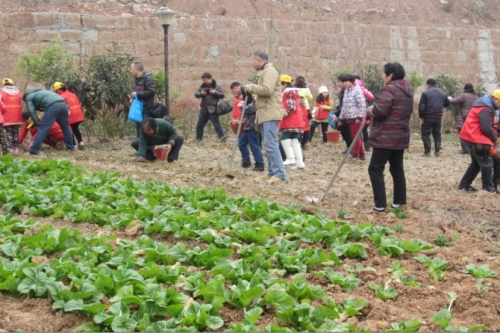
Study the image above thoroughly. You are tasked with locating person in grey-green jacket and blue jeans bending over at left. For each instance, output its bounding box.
[23,88,74,155]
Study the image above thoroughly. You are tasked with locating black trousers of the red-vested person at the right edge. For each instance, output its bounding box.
[458,145,495,192]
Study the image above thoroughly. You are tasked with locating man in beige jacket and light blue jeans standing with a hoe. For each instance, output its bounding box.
[241,51,286,183]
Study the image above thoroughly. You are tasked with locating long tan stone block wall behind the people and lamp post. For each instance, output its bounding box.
[0,13,500,94]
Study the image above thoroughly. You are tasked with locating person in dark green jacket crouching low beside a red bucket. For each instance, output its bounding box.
[132,117,184,163]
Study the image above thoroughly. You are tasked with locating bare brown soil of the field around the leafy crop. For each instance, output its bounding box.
[0,134,500,331]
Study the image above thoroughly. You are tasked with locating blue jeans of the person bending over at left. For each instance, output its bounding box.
[30,102,74,155]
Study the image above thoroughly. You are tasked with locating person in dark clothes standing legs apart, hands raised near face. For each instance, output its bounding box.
[194,72,226,142]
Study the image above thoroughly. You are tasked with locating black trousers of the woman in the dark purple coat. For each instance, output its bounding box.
[368,148,406,208]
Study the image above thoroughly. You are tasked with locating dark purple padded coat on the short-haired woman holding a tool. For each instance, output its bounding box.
[368,79,413,150]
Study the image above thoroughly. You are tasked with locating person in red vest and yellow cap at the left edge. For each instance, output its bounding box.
[0,78,23,154]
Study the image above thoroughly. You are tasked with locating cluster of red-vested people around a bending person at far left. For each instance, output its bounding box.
[0,78,84,155]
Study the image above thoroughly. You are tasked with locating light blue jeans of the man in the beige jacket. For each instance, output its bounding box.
[261,120,286,180]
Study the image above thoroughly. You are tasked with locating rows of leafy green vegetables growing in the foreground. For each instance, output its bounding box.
[0,157,496,332]
